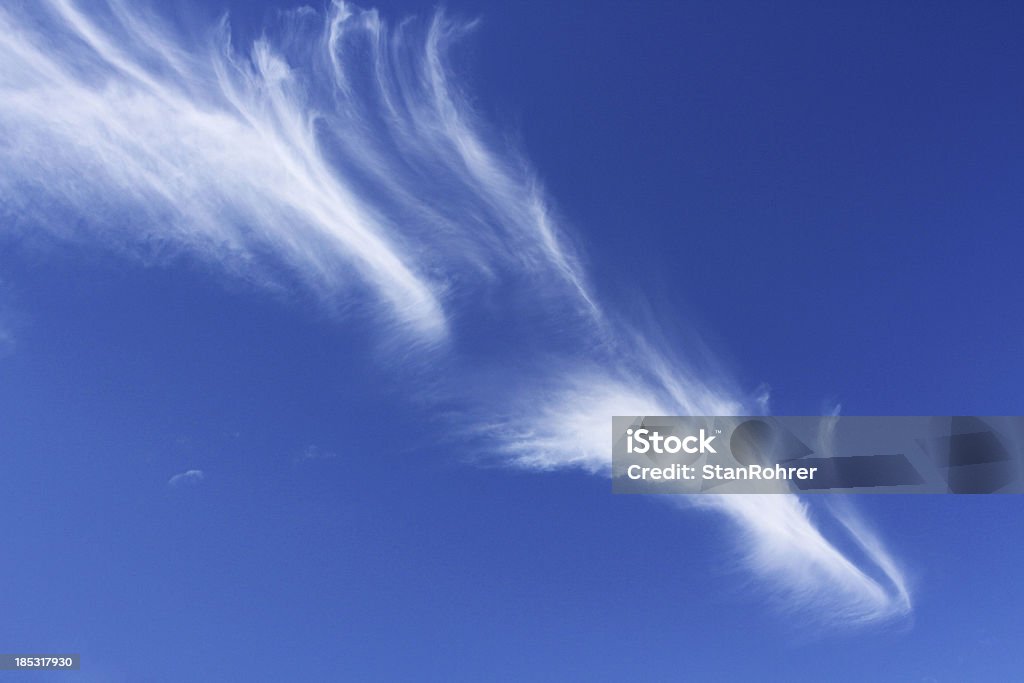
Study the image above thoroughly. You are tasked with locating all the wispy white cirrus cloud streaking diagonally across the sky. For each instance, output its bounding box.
[0,0,910,624]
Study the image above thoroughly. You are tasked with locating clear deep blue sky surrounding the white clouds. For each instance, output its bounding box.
[0,3,1024,681]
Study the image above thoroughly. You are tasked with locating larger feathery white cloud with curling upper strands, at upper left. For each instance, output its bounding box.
[0,0,590,341]
